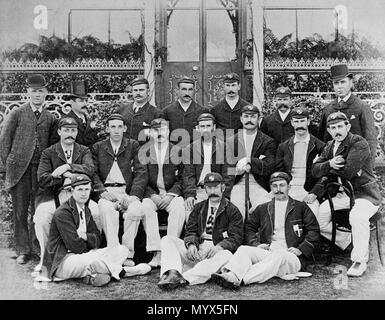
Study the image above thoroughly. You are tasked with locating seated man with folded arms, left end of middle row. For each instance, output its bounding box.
[33,117,101,272]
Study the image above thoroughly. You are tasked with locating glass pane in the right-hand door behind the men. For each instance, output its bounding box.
[206,10,238,62]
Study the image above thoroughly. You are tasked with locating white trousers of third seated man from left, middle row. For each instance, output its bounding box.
[143,197,186,238]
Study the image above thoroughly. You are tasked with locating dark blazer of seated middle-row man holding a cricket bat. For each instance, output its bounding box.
[226,130,277,191]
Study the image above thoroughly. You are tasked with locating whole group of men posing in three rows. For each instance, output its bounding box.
[0,65,381,289]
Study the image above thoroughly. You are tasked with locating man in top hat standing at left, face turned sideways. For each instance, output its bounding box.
[65,80,98,147]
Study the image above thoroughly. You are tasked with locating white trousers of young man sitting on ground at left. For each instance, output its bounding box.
[54,245,128,281]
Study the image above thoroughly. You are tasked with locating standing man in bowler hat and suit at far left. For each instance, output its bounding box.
[0,74,58,264]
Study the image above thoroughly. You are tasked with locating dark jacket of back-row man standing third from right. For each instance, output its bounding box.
[211,98,250,132]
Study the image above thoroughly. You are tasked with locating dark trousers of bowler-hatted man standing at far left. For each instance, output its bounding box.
[10,164,39,255]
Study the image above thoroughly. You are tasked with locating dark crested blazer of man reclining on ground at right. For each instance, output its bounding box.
[245,197,320,269]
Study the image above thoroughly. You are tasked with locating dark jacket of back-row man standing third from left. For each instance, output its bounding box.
[118,102,164,144]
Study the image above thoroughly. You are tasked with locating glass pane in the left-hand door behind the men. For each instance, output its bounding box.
[167,10,199,61]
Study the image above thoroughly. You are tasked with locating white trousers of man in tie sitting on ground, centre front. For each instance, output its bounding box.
[160,236,232,285]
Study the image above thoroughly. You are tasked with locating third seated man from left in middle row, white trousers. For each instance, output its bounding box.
[143,118,186,268]
